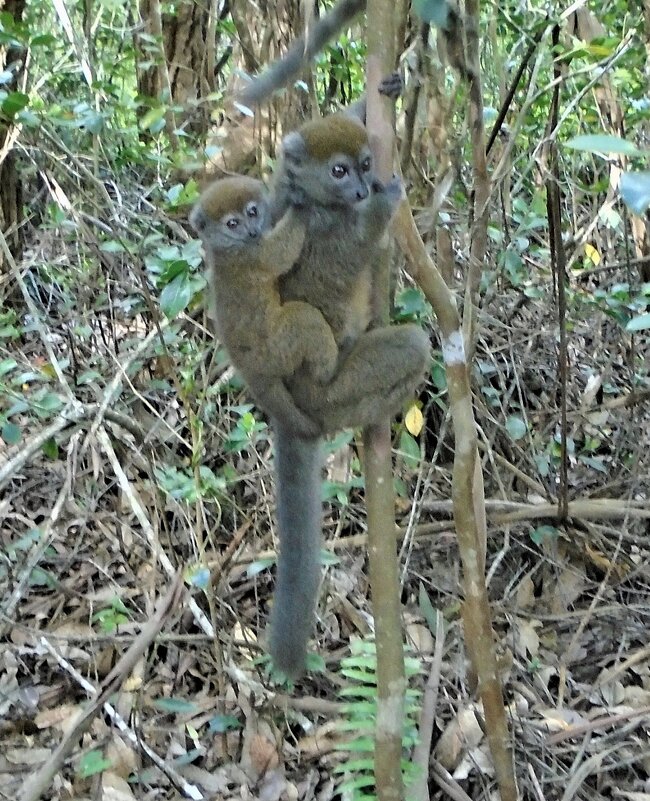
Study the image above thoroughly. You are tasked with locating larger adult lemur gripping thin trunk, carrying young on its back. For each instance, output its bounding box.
[270,113,429,677]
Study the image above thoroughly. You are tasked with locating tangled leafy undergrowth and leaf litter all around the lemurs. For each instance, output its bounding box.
[0,3,650,801]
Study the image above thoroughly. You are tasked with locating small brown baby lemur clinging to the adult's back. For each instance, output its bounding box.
[190,176,338,437]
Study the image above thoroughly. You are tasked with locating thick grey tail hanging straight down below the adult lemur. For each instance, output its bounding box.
[270,426,322,678]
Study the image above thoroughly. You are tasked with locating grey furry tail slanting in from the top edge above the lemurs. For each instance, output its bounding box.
[238,0,366,106]
